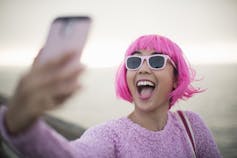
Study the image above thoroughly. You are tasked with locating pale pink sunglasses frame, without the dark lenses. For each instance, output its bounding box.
[125,54,176,70]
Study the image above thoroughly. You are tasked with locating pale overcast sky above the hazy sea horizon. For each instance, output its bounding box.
[0,0,237,66]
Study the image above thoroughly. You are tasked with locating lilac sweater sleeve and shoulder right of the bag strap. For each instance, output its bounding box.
[186,111,221,158]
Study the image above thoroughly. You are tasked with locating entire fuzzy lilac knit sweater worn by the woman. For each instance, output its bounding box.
[0,108,221,158]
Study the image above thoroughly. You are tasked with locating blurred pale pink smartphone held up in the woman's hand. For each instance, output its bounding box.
[38,16,91,66]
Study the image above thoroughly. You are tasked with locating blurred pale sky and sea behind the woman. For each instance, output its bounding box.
[0,0,237,157]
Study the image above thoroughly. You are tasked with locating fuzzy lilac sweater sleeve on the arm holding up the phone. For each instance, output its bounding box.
[0,108,113,158]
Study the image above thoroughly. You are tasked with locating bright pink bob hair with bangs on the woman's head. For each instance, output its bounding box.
[115,35,202,108]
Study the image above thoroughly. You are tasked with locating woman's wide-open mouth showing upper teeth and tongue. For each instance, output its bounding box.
[136,80,156,99]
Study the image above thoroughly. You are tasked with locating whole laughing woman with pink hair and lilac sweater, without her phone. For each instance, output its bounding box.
[0,35,221,158]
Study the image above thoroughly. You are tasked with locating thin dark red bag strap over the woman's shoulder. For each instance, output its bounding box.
[177,110,196,157]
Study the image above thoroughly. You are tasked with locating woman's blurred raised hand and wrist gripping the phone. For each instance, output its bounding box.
[5,53,83,135]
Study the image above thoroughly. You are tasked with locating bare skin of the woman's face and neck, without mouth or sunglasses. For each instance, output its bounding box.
[126,50,176,131]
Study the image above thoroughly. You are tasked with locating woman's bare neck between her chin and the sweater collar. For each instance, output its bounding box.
[128,103,169,131]
